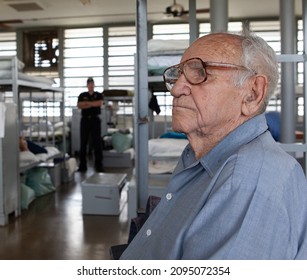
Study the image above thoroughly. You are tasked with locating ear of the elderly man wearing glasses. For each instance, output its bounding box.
[242,75,267,116]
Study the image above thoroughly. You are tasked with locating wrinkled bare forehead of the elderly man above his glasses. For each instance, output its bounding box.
[181,33,242,64]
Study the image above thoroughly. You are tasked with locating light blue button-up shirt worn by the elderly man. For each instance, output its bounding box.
[122,115,307,259]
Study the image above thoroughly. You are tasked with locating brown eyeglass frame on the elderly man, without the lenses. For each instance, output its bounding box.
[163,57,257,91]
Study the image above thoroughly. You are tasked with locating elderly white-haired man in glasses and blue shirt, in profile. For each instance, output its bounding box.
[122,29,307,259]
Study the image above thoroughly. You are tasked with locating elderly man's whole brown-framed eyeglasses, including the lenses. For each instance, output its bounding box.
[163,57,256,91]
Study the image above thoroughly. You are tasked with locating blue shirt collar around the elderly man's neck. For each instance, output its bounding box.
[199,114,268,176]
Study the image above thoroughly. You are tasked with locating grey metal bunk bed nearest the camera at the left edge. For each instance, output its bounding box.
[0,56,66,225]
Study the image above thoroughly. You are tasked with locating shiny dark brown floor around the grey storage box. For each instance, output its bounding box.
[0,166,130,260]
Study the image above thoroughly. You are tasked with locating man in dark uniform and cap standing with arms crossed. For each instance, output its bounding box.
[77,77,103,172]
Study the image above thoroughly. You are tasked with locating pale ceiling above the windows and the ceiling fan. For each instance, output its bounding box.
[0,0,302,30]
